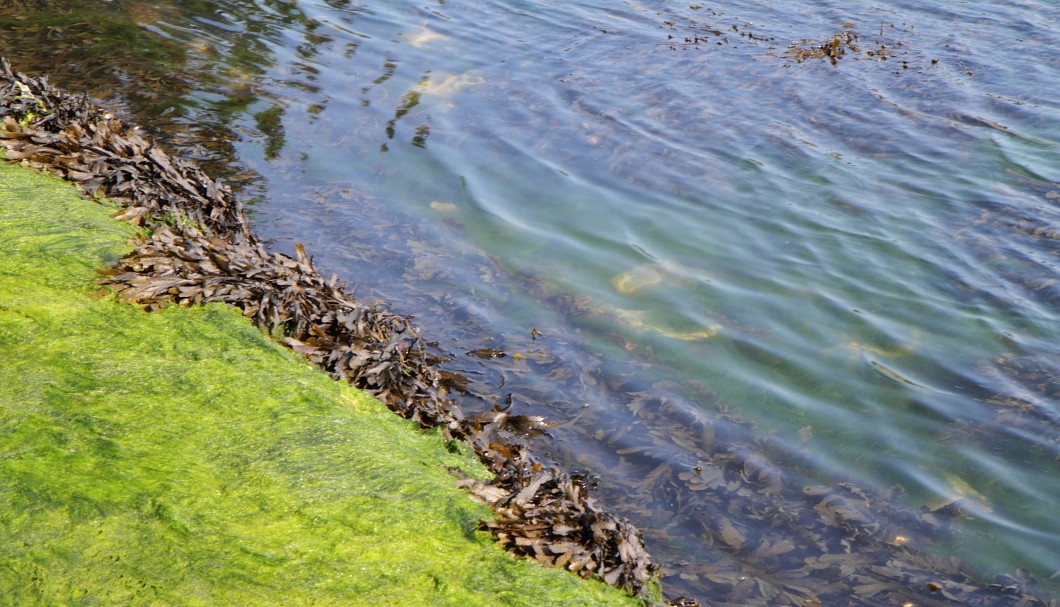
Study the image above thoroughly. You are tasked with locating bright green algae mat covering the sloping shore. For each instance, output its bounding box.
[0,165,640,607]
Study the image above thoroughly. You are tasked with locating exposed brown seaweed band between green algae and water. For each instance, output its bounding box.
[0,59,656,595]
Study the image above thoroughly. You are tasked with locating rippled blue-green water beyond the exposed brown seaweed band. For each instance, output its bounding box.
[0,0,1060,605]
